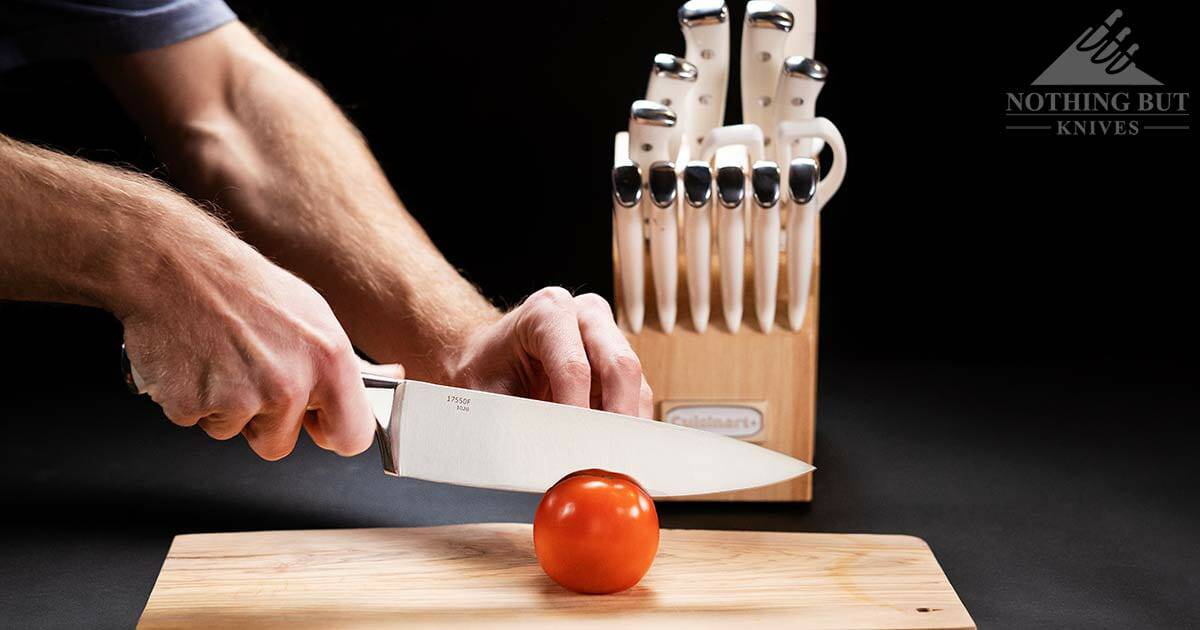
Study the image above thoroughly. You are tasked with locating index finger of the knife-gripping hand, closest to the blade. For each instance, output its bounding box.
[306,342,376,456]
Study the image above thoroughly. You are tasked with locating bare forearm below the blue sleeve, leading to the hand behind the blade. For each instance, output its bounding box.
[96,25,498,379]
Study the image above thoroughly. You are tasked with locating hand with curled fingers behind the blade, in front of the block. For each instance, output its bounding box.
[451,287,654,418]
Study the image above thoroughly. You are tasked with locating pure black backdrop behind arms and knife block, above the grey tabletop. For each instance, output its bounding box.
[0,1,1198,370]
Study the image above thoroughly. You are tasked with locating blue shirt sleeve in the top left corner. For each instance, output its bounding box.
[0,0,238,72]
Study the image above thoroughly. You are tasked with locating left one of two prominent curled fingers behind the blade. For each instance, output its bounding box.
[516,287,592,407]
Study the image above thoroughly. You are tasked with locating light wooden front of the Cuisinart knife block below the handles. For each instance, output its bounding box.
[613,220,821,502]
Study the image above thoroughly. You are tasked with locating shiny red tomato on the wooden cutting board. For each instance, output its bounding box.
[533,468,659,593]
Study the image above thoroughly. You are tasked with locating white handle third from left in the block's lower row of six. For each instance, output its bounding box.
[683,161,713,332]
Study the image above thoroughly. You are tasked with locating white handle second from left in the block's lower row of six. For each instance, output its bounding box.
[649,162,679,332]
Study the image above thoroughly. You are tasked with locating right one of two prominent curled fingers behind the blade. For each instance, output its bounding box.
[575,293,649,415]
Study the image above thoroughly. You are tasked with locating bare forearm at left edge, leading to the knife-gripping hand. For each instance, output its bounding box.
[0,136,250,318]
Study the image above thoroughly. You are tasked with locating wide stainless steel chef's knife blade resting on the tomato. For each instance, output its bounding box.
[372,380,812,497]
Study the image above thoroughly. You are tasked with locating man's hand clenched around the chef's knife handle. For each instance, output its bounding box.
[122,238,374,461]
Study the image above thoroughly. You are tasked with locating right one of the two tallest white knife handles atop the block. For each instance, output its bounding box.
[742,0,794,158]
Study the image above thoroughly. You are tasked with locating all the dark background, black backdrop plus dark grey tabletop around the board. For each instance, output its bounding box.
[0,1,1200,628]
